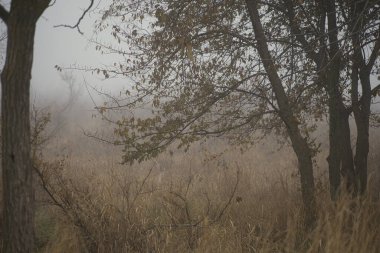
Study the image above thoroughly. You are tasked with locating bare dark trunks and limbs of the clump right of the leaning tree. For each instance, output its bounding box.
[283,0,380,199]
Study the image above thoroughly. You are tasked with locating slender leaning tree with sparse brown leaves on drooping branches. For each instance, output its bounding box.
[93,0,322,227]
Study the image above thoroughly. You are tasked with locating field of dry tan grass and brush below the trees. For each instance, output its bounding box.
[29,128,380,253]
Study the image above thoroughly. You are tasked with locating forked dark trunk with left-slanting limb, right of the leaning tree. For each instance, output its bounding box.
[283,0,355,199]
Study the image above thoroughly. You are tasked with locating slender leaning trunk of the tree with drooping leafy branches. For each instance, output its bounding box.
[246,0,317,229]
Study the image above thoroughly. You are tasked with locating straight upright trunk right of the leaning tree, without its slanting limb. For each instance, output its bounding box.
[324,0,356,200]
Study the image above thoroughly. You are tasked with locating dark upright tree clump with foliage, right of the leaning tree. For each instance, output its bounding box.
[276,0,380,199]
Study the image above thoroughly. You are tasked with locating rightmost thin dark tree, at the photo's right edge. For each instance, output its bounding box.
[344,1,380,194]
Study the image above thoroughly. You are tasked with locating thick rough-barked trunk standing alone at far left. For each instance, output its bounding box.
[1,0,49,253]
